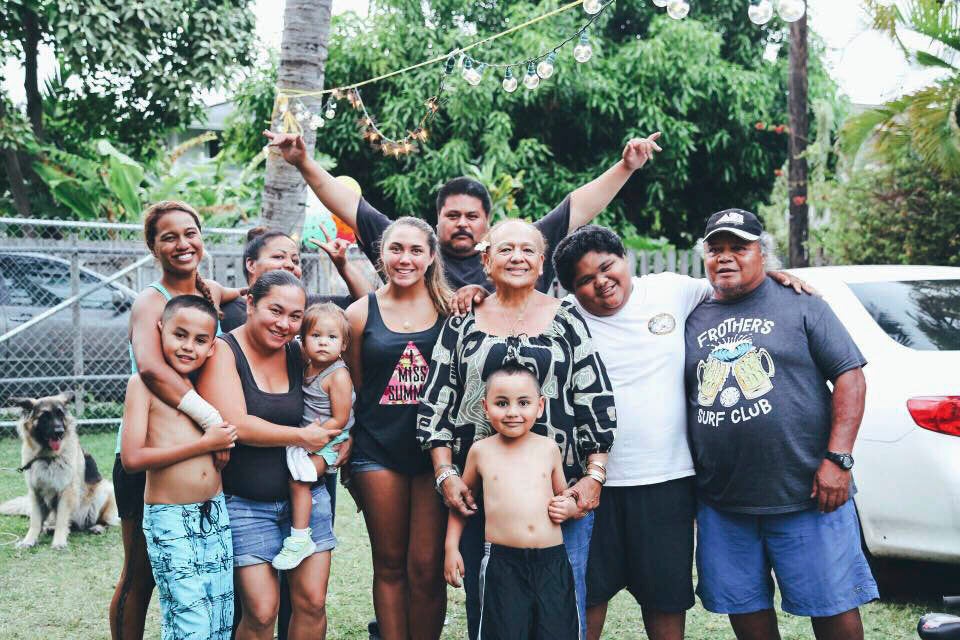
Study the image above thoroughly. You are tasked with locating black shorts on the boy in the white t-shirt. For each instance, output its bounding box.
[587,476,697,613]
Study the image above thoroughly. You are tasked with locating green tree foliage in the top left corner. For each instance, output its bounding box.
[0,0,254,152]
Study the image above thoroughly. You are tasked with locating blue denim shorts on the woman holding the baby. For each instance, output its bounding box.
[227,484,337,567]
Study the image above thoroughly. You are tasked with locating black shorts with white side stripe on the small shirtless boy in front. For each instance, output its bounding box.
[480,542,580,640]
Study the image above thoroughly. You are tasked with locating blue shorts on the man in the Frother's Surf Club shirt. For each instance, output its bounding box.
[697,499,880,618]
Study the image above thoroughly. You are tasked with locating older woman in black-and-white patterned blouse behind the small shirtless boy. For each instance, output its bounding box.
[417,220,616,638]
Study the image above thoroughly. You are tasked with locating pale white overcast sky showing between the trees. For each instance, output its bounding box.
[3,0,935,109]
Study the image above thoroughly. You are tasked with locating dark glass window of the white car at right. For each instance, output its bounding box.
[849,280,960,351]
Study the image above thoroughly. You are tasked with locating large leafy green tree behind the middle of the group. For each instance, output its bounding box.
[225,0,836,244]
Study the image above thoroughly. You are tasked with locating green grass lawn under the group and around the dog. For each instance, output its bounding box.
[0,434,938,640]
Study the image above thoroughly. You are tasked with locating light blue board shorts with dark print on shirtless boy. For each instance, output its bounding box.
[143,493,233,640]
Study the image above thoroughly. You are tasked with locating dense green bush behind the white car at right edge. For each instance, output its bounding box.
[812,154,960,266]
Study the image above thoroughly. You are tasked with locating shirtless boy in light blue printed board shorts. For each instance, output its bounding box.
[120,296,237,640]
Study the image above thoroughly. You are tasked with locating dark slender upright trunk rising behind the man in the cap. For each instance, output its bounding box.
[787,16,810,267]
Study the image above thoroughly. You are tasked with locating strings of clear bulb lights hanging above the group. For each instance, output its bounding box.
[272,0,806,158]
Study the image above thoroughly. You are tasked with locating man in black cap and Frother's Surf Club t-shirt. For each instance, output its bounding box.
[685,209,878,640]
